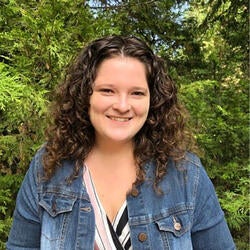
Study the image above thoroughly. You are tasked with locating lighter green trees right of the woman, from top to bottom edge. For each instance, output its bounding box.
[182,0,249,249]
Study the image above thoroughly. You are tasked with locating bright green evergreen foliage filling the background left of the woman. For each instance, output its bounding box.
[0,0,95,249]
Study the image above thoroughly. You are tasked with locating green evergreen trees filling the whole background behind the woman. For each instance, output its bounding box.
[0,0,249,249]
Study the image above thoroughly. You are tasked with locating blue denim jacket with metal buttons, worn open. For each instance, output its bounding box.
[7,147,235,250]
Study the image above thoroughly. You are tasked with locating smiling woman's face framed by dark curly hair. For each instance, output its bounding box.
[89,56,150,143]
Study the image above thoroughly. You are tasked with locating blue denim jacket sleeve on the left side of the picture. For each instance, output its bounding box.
[7,151,41,250]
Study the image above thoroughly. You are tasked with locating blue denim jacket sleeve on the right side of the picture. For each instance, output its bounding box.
[192,166,236,250]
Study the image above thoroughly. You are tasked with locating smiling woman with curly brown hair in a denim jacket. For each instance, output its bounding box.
[7,36,235,250]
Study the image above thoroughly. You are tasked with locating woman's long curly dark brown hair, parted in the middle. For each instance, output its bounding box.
[43,36,189,189]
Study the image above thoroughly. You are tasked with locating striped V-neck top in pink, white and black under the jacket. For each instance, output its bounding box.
[83,165,132,250]
